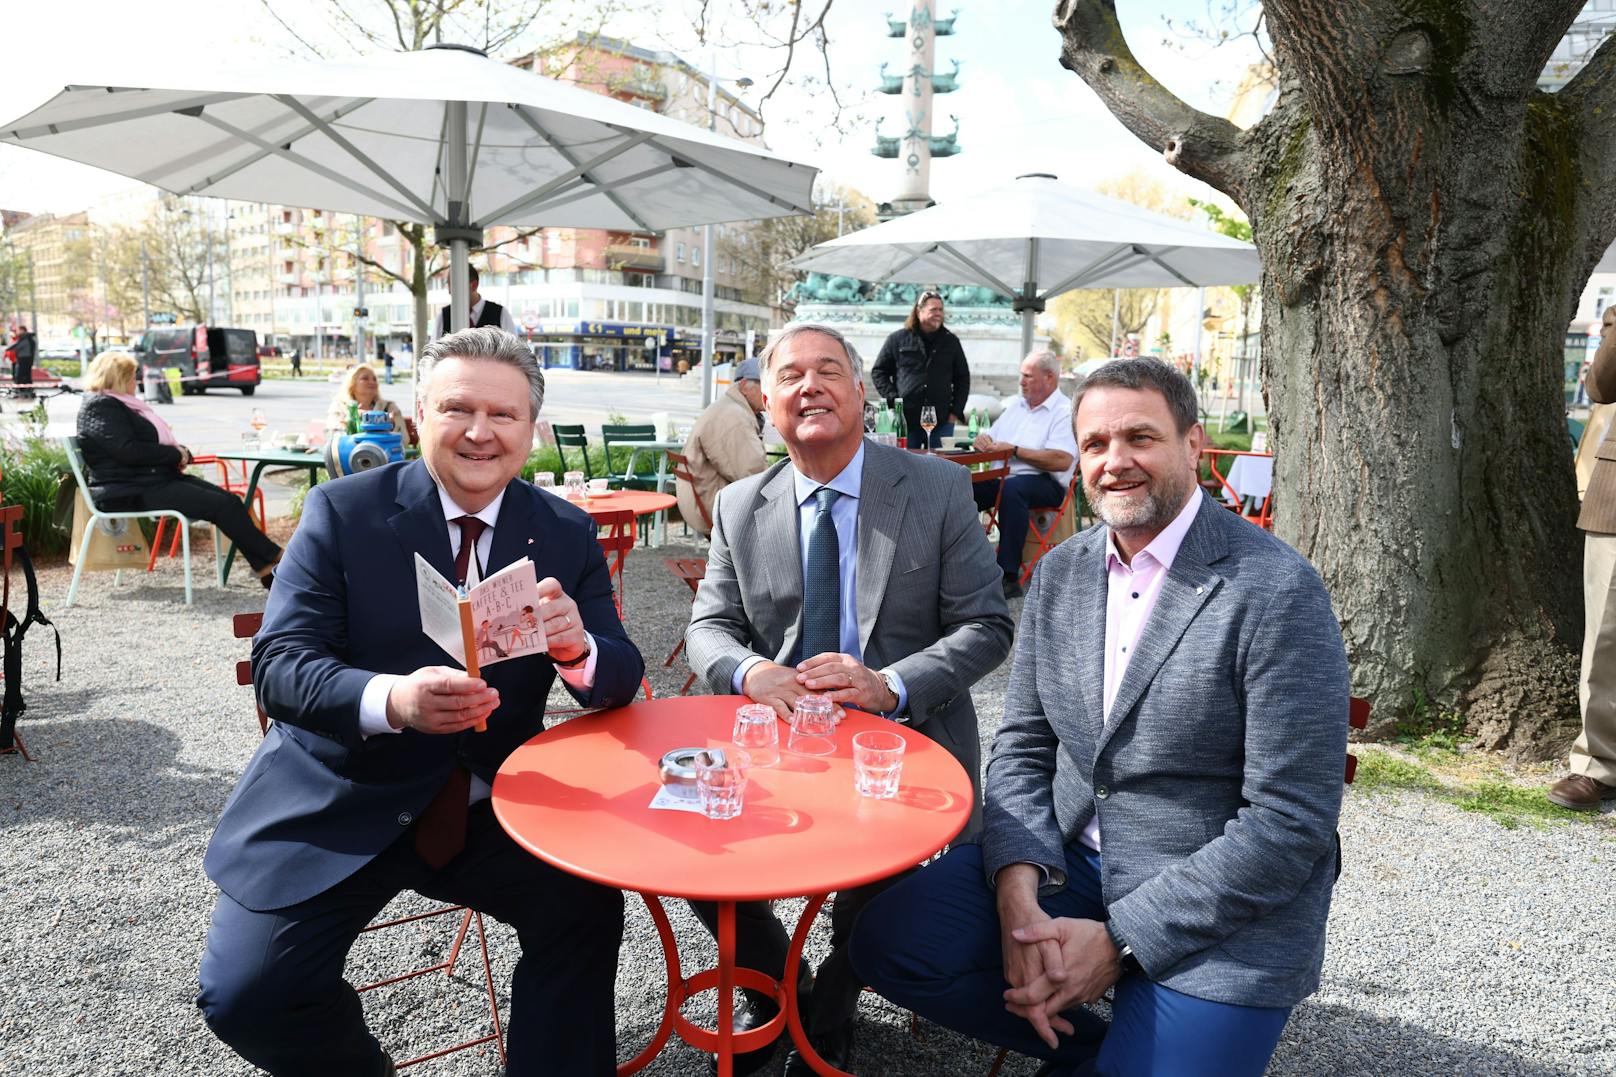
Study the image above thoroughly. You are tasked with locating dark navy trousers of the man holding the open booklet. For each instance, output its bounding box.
[197,800,622,1077]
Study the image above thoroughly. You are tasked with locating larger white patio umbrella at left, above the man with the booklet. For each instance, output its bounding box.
[0,45,816,336]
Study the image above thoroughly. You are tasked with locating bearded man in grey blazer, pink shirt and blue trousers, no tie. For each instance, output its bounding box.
[852,359,1349,1075]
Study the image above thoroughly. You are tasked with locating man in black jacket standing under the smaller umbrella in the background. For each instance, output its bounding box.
[869,291,971,448]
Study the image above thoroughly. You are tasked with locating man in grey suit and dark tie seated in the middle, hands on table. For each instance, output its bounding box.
[685,325,1012,1074]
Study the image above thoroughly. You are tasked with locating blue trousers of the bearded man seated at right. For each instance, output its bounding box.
[852,843,1291,1077]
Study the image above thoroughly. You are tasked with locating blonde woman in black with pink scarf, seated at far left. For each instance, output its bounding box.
[79,351,281,589]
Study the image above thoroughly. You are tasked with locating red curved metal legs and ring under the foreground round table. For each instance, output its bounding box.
[617,893,852,1077]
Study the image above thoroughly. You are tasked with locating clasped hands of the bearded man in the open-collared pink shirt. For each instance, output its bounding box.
[995,864,1122,1048]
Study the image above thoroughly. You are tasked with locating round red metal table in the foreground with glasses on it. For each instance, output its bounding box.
[493,692,971,1077]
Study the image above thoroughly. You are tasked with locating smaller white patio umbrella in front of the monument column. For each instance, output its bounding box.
[790,173,1260,354]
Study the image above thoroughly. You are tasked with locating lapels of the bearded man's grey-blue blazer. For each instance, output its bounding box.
[1096,498,1227,755]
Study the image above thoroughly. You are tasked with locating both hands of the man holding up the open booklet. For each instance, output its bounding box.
[388,576,588,733]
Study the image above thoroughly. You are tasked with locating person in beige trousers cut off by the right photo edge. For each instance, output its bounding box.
[1548,307,1616,812]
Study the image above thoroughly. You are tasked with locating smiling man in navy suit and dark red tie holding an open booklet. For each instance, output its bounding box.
[197,328,645,1077]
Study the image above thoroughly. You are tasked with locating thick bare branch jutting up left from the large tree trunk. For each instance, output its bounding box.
[1055,0,1248,209]
